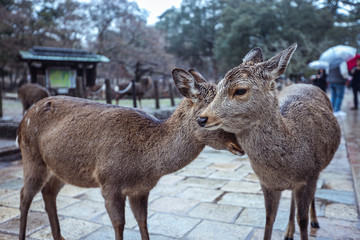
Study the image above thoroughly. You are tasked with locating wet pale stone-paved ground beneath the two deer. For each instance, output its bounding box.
[0,88,360,240]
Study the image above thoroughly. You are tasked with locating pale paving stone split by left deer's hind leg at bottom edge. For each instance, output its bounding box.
[30,218,101,240]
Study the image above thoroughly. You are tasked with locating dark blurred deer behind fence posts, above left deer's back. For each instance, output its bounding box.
[113,77,152,108]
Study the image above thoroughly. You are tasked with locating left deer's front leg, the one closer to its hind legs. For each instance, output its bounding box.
[102,186,126,240]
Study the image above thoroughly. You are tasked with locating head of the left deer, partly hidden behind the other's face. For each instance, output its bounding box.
[172,68,244,155]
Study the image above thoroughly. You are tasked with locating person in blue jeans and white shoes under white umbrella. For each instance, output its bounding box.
[327,61,348,117]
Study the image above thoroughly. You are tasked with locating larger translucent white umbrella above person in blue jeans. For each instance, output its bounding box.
[319,45,356,68]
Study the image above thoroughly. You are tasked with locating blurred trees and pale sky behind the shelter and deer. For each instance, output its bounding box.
[0,0,360,91]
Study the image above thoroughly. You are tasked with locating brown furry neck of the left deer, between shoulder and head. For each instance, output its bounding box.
[155,99,205,176]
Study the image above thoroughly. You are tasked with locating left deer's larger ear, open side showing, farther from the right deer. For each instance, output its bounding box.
[171,68,200,100]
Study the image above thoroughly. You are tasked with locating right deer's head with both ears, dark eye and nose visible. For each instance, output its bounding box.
[198,44,297,133]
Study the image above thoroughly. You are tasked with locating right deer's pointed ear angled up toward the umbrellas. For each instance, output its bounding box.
[264,43,297,80]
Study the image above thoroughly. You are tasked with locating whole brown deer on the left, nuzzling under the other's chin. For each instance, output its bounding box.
[18,69,243,239]
